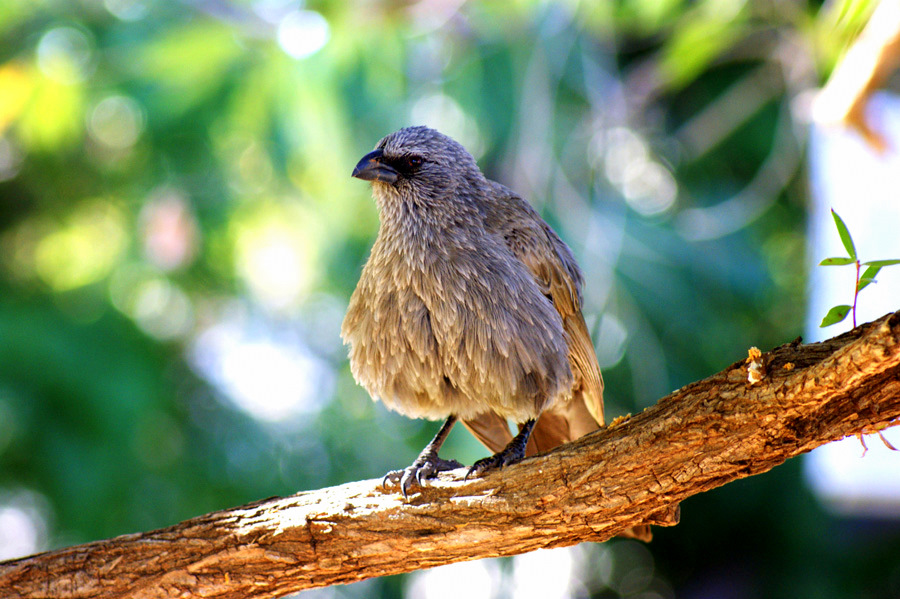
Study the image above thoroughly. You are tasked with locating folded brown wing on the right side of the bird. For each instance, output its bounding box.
[485,184,603,451]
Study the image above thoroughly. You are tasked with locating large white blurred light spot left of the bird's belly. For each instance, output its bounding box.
[190,310,333,422]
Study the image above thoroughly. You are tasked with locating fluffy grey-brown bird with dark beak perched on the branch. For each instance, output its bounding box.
[341,126,652,540]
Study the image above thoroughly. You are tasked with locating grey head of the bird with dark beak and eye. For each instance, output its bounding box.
[352,127,481,199]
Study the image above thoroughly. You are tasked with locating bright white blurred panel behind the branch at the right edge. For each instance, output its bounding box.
[804,92,900,517]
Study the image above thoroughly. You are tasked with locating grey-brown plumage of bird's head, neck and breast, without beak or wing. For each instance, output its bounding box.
[341,128,573,422]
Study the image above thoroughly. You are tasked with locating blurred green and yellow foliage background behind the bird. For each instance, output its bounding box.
[0,0,900,597]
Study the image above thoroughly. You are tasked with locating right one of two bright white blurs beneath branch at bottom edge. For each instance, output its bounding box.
[512,547,576,599]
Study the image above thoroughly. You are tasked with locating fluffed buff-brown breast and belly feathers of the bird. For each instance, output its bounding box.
[342,237,572,421]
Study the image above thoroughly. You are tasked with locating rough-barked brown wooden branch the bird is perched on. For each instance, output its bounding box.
[0,312,900,599]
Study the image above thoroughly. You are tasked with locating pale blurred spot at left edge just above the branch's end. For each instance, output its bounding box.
[0,489,48,561]
